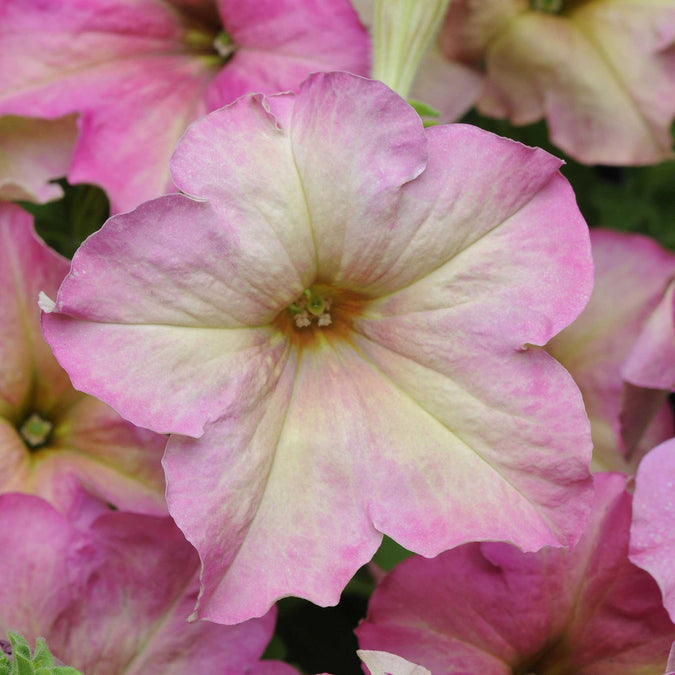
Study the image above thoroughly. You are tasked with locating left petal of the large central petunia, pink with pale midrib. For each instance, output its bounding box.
[43,195,303,436]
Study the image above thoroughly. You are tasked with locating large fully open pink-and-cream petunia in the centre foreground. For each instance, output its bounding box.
[42,73,592,622]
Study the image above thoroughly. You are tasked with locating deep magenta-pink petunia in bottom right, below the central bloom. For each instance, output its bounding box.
[356,474,675,675]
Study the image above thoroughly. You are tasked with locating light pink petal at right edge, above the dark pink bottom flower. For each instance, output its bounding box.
[630,440,675,620]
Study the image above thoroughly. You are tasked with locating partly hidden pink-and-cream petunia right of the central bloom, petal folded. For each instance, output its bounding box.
[546,229,675,473]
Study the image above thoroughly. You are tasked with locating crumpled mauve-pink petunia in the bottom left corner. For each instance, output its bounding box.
[0,494,295,675]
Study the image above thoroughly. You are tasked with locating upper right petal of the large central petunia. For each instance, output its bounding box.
[342,125,592,314]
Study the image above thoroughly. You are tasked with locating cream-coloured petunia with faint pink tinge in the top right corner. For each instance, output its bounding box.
[436,0,675,165]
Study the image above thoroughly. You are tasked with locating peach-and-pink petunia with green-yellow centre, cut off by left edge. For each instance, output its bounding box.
[0,203,166,518]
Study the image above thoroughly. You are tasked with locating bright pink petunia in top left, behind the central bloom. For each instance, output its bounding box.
[0,0,369,211]
